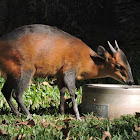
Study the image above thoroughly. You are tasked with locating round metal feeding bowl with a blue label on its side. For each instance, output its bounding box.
[81,84,140,118]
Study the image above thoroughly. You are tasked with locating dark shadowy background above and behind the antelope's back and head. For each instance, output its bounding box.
[0,0,140,84]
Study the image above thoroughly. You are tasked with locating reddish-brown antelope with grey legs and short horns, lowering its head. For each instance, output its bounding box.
[0,24,133,120]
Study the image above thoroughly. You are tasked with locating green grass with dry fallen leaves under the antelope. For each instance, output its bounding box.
[0,78,140,140]
